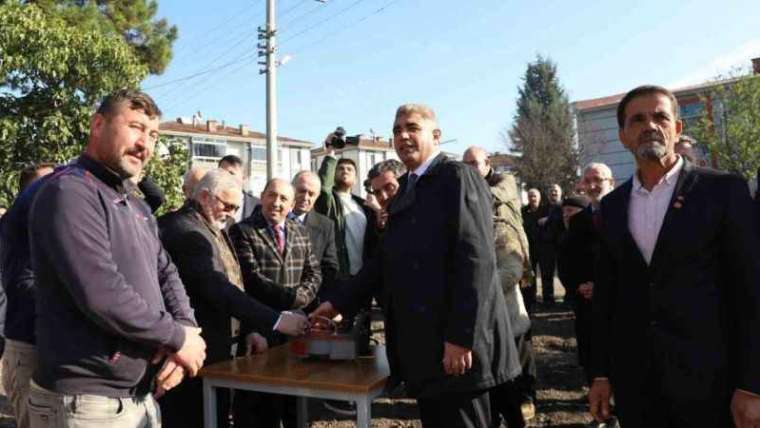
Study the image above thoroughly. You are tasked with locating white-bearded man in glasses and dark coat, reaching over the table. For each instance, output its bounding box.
[161,169,307,428]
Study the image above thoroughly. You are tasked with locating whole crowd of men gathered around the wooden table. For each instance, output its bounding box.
[0,86,760,428]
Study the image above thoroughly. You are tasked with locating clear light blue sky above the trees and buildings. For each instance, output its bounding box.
[143,0,760,152]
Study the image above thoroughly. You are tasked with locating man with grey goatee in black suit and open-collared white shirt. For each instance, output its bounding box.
[589,86,760,428]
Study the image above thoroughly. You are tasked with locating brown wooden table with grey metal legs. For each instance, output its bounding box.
[200,344,390,428]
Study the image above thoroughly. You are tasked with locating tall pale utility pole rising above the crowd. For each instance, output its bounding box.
[266,0,277,181]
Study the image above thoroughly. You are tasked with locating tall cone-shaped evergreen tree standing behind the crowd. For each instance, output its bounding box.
[507,56,578,196]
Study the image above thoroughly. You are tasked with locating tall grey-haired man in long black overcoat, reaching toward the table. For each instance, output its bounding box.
[314,104,520,427]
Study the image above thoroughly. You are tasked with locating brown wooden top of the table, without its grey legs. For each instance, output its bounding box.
[200,344,390,393]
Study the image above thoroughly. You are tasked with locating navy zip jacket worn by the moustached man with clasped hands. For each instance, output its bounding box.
[29,155,197,397]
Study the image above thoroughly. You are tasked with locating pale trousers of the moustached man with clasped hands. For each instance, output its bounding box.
[28,381,161,428]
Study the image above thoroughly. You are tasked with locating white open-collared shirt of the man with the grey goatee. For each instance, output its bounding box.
[628,156,683,264]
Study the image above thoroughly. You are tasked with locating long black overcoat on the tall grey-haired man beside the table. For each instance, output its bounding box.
[331,155,520,397]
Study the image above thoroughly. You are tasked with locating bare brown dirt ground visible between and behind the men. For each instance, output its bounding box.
[0,284,591,428]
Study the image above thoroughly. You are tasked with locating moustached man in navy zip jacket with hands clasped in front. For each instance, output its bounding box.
[29,90,206,427]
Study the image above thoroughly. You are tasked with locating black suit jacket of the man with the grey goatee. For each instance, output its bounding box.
[592,162,760,428]
